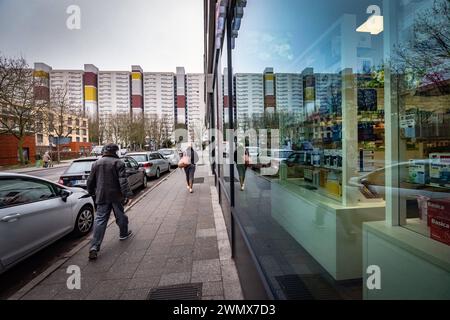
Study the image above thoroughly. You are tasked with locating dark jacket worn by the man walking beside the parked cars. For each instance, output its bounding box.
[87,155,132,204]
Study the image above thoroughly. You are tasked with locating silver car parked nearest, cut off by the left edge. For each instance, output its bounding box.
[0,173,94,273]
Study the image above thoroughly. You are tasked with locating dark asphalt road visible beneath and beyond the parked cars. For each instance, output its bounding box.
[0,168,170,300]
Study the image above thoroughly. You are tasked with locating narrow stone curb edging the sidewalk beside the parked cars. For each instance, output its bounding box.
[7,169,178,300]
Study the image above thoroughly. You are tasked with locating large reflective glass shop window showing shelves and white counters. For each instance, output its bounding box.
[212,0,450,299]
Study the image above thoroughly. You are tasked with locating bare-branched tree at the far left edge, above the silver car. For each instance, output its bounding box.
[0,56,48,164]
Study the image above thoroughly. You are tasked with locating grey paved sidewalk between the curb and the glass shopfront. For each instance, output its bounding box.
[15,165,243,300]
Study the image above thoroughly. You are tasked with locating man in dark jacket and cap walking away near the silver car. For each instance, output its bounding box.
[87,144,132,260]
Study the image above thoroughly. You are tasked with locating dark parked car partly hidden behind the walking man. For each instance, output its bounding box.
[59,156,147,191]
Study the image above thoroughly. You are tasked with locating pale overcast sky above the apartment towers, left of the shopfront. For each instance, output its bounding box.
[0,0,203,72]
